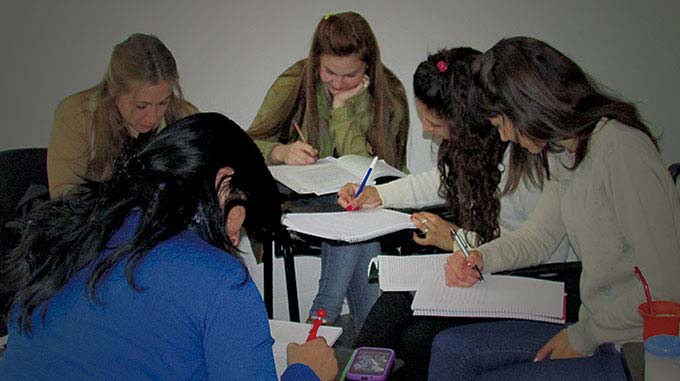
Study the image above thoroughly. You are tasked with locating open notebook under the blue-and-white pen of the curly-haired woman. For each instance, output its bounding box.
[282,208,415,242]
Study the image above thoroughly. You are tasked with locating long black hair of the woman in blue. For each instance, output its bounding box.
[0,113,281,333]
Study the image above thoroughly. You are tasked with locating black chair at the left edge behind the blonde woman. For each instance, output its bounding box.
[0,148,48,336]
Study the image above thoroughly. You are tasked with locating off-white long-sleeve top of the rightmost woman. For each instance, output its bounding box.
[479,120,680,354]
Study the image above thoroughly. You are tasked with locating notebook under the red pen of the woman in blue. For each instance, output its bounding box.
[269,320,342,377]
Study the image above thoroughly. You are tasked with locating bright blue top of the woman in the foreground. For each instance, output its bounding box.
[0,215,317,380]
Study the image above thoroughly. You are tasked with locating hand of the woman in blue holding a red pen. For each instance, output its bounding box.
[286,337,338,380]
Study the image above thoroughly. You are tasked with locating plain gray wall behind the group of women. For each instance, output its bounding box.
[0,0,680,171]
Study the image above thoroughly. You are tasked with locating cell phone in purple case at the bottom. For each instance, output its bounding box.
[345,347,395,381]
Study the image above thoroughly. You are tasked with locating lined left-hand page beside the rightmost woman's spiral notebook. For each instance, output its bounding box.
[375,254,449,291]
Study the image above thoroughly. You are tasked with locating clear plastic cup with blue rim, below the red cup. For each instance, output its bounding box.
[645,335,680,381]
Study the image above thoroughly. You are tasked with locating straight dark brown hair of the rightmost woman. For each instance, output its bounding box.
[471,37,658,182]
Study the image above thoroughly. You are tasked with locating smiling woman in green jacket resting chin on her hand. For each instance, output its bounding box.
[248,12,409,328]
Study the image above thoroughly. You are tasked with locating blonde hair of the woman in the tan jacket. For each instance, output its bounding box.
[86,33,193,179]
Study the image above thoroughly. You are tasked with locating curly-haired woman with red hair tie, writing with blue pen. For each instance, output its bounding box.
[339,48,569,380]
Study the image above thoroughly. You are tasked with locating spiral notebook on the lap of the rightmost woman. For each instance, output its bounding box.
[411,271,566,323]
